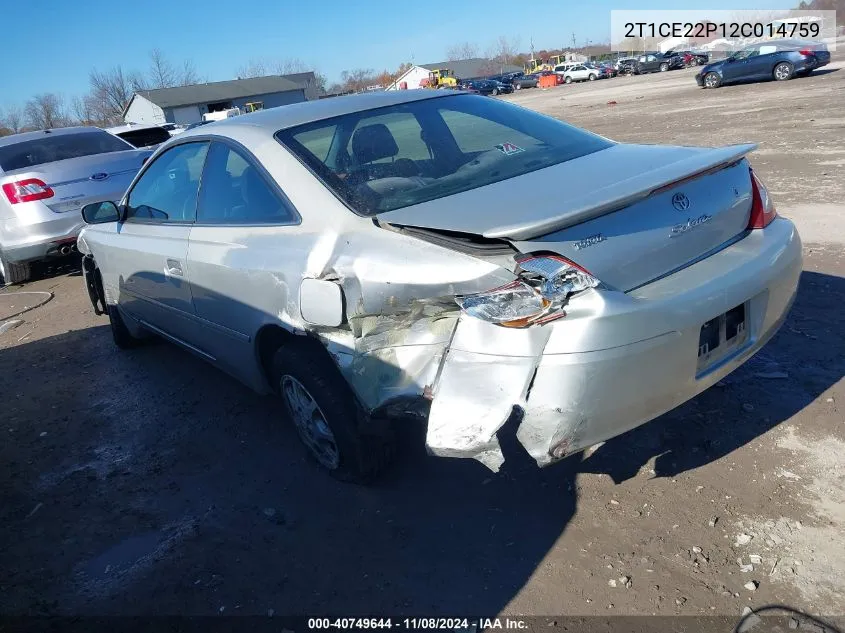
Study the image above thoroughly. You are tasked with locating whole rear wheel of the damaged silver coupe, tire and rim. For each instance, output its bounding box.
[272,342,393,483]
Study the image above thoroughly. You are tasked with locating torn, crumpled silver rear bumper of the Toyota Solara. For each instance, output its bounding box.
[426,218,802,470]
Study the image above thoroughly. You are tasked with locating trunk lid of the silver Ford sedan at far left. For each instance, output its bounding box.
[0,150,152,213]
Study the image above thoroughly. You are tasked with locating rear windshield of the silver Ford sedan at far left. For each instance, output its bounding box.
[0,130,132,171]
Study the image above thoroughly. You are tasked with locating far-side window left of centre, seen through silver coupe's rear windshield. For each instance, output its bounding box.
[347,112,428,165]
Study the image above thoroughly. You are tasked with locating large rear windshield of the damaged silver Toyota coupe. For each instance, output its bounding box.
[276,95,612,216]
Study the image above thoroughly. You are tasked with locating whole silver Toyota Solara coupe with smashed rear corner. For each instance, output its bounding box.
[79,90,801,481]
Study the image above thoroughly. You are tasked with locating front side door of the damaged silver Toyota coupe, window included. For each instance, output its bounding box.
[108,142,208,340]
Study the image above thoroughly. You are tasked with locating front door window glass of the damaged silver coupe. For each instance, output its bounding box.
[126,143,208,222]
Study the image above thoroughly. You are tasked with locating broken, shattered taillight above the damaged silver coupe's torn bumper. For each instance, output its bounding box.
[455,255,600,328]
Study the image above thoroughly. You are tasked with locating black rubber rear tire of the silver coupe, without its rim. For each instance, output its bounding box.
[271,342,394,484]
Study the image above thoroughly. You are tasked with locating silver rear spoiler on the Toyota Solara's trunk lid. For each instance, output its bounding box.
[483,143,757,240]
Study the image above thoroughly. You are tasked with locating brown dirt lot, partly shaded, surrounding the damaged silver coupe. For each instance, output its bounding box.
[0,53,845,617]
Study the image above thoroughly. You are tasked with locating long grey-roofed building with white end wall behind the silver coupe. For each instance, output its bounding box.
[123,72,318,124]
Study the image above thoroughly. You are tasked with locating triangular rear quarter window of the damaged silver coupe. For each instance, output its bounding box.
[197,143,296,224]
